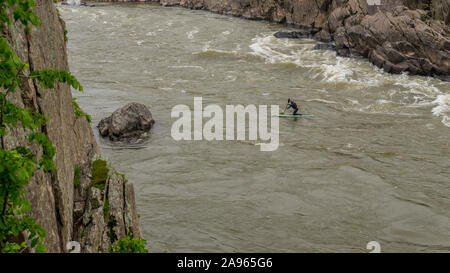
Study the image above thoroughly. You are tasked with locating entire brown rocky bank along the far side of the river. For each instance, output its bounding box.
[160,0,450,79]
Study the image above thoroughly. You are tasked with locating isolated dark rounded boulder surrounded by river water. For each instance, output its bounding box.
[97,102,155,141]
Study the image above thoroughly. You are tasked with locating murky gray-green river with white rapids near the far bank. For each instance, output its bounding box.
[58,4,450,252]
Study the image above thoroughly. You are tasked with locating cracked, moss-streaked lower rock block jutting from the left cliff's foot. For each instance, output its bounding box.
[73,169,142,253]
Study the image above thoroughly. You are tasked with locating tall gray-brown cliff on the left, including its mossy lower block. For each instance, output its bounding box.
[1,0,141,252]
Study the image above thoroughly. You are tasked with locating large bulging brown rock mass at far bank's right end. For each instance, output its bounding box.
[333,3,450,77]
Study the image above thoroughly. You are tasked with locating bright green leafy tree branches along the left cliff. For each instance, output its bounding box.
[0,0,82,253]
